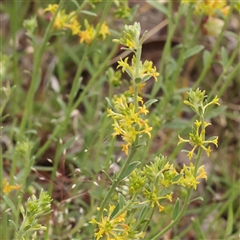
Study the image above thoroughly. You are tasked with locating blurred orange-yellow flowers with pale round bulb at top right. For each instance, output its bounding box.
[182,0,230,37]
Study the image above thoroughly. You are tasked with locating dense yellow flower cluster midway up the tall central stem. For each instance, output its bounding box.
[107,95,152,155]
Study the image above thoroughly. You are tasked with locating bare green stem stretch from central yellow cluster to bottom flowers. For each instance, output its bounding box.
[97,145,137,221]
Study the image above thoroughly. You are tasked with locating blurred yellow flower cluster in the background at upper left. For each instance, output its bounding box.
[44,4,110,45]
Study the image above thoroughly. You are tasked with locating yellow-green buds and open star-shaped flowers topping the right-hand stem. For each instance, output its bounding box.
[178,89,220,160]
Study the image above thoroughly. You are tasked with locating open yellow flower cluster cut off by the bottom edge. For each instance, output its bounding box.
[90,205,145,240]
